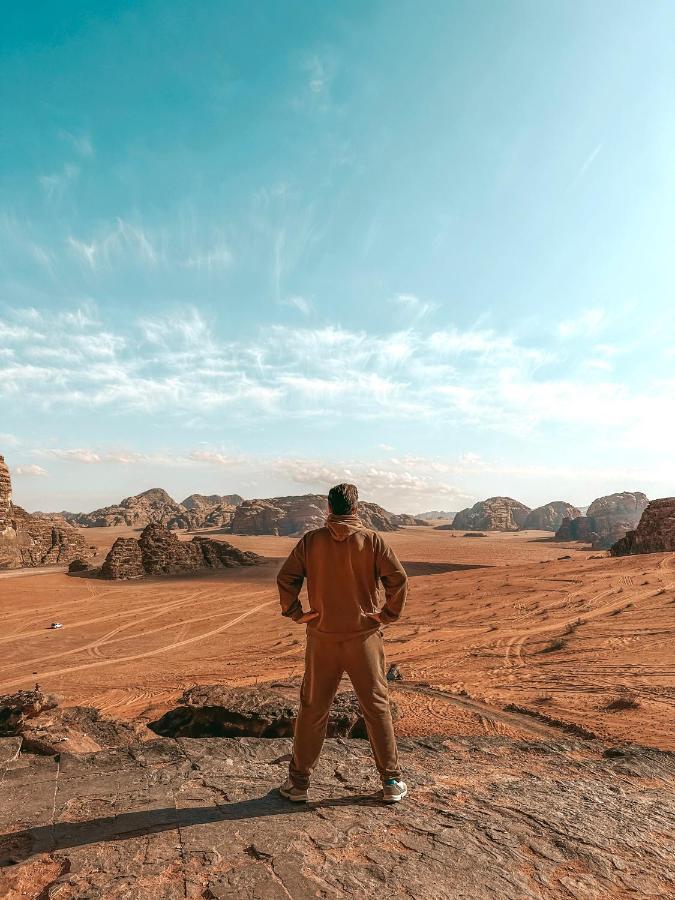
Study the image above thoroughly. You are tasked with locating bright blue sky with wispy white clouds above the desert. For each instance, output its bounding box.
[0,0,675,511]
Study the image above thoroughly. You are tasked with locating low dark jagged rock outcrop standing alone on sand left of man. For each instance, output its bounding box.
[101,524,261,579]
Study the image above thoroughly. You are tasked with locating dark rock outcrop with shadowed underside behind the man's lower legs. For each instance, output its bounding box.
[149,685,395,738]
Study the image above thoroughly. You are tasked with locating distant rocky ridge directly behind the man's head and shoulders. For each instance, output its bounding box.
[230,494,426,536]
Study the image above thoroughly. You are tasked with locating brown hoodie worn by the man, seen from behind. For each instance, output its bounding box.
[277,514,408,640]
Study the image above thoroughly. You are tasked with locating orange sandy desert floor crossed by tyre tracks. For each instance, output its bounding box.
[0,527,675,749]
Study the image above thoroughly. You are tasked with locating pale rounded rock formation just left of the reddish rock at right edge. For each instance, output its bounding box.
[555,491,649,549]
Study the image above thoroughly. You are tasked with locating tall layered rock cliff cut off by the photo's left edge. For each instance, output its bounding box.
[0,456,93,569]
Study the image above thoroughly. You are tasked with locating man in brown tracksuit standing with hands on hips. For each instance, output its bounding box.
[277,484,408,803]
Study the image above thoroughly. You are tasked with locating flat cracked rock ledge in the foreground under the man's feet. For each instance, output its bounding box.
[0,736,675,900]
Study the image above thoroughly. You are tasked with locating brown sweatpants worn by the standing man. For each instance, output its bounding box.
[289,629,401,790]
